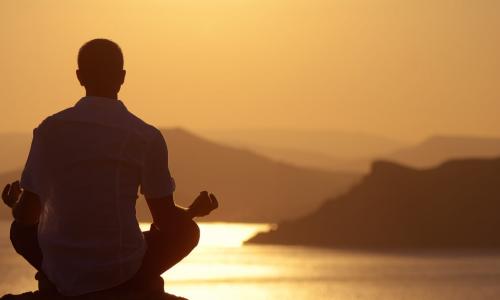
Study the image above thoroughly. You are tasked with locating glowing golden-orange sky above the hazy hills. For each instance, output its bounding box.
[0,0,500,140]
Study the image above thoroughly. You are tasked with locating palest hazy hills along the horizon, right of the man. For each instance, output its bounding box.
[199,129,500,173]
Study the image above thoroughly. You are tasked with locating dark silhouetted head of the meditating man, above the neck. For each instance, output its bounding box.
[78,39,125,94]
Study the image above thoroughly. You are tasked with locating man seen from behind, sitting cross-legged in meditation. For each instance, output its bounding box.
[2,39,218,296]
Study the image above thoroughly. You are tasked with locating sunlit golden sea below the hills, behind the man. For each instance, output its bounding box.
[0,222,500,300]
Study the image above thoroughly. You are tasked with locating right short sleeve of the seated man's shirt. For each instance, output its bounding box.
[141,131,175,199]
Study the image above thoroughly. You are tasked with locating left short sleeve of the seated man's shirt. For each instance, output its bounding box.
[20,128,44,196]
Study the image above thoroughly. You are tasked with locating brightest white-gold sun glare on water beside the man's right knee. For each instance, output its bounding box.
[141,223,277,291]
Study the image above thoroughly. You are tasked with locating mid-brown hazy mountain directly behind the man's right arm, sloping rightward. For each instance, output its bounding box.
[0,129,359,222]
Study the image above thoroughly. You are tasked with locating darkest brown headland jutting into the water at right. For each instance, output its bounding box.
[250,159,500,250]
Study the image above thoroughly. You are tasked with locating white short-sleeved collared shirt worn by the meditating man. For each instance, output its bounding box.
[21,97,175,296]
